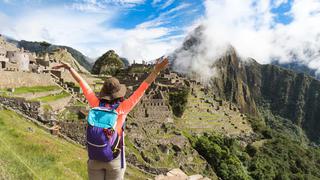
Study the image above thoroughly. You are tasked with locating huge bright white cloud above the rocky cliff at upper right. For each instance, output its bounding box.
[174,0,320,79]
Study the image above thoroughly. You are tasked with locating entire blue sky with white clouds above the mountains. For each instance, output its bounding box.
[0,0,319,68]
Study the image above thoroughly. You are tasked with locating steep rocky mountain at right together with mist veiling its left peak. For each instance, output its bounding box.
[172,26,320,145]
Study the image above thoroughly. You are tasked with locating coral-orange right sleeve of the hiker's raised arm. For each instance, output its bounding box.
[121,82,149,114]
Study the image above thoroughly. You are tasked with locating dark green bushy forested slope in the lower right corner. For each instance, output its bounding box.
[190,109,320,180]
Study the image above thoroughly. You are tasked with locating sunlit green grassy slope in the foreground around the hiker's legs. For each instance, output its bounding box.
[0,110,149,180]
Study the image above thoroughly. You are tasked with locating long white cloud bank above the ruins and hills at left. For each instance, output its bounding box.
[0,3,184,61]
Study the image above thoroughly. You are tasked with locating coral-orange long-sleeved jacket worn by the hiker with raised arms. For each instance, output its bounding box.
[80,80,149,134]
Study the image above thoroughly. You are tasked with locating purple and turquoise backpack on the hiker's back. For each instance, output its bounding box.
[87,103,124,168]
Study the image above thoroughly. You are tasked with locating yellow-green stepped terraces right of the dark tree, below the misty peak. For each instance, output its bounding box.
[177,87,251,135]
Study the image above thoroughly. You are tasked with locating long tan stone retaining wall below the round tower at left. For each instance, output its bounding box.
[0,71,55,89]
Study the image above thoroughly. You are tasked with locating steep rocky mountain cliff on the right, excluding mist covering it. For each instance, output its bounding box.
[173,27,320,142]
